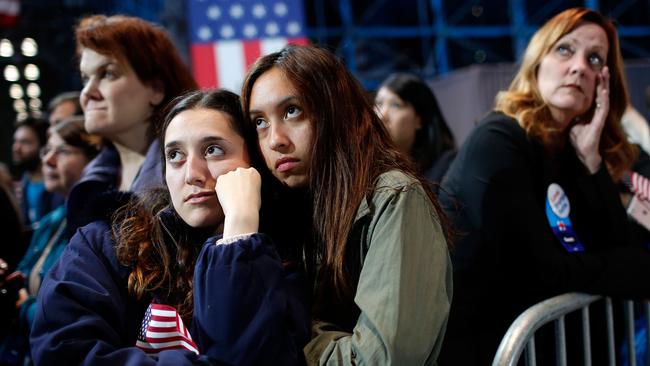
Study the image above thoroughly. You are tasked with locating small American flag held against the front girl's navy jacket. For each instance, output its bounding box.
[135,303,199,355]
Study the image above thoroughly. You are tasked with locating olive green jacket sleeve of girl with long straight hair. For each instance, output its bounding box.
[305,184,452,365]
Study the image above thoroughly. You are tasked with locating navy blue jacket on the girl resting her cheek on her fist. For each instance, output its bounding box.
[31,217,309,366]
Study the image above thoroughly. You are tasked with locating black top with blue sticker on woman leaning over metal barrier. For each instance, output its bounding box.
[440,113,650,365]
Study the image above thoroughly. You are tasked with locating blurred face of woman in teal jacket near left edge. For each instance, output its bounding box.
[41,132,90,197]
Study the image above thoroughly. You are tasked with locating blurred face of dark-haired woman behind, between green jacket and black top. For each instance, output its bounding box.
[375,87,422,155]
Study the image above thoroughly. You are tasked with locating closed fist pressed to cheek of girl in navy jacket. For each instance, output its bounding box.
[215,168,262,238]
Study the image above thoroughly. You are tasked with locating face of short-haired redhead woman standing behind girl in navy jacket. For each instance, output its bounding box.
[79,48,164,142]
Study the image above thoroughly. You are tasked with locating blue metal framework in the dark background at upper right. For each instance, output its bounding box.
[306,0,650,89]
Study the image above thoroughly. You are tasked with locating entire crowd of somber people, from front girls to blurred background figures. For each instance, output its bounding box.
[0,8,650,365]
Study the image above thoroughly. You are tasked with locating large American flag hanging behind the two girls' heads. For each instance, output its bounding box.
[188,0,307,92]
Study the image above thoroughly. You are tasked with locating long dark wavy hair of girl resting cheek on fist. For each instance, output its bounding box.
[112,90,259,318]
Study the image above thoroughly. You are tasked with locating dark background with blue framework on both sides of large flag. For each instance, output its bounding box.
[0,0,650,162]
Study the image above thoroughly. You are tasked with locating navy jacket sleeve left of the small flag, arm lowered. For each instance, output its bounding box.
[30,222,218,366]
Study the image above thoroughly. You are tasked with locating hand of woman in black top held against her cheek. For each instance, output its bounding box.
[569,66,609,174]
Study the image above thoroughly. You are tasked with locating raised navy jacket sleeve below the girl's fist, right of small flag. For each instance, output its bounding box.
[193,234,309,365]
